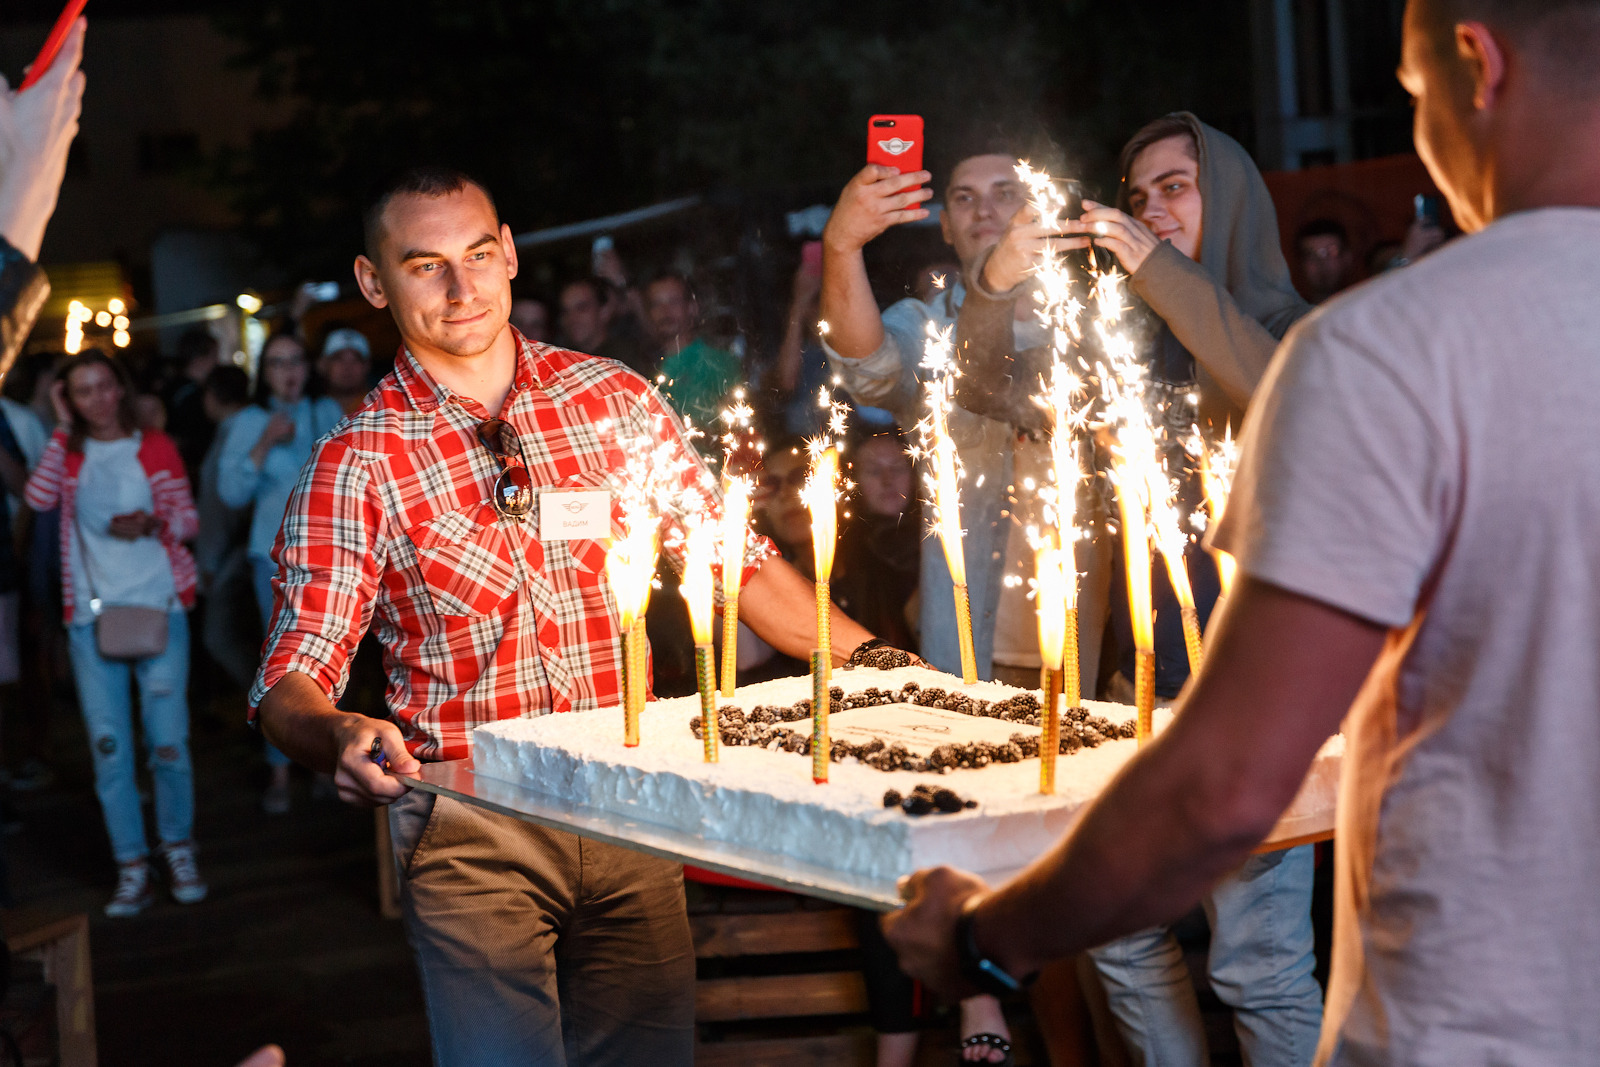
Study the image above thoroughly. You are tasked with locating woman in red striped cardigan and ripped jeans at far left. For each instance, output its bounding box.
[26,350,206,915]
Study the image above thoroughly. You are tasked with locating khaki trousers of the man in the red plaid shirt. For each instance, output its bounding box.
[389,790,694,1067]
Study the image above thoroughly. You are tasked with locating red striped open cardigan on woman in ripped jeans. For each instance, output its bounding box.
[24,429,200,624]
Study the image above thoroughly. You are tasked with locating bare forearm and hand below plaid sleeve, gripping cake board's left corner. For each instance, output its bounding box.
[258,670,422,806]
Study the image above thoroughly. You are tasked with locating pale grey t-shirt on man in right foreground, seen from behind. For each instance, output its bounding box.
[1216,208,1600,1067]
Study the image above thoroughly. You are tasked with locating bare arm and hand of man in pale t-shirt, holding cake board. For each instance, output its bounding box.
[885,577,1387,992]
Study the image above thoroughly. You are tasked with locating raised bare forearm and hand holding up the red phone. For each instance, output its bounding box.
[821,163,933,360]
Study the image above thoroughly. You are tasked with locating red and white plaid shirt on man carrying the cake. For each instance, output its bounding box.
[250,334,774,760]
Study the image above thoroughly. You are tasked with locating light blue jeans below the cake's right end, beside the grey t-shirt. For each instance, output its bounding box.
[1090,845,1322,1067]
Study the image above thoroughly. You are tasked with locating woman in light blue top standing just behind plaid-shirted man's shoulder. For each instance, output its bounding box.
[216,333,344,814]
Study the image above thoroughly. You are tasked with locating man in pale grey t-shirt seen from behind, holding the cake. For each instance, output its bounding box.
[886,0,1600,1065]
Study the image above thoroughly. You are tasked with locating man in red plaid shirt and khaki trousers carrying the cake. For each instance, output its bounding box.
[251,170,870,1067]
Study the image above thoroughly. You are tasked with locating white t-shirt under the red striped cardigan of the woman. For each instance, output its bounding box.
[69,434,178,622]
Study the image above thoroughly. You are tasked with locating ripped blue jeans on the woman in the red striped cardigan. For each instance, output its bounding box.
[67,609,195,864]
